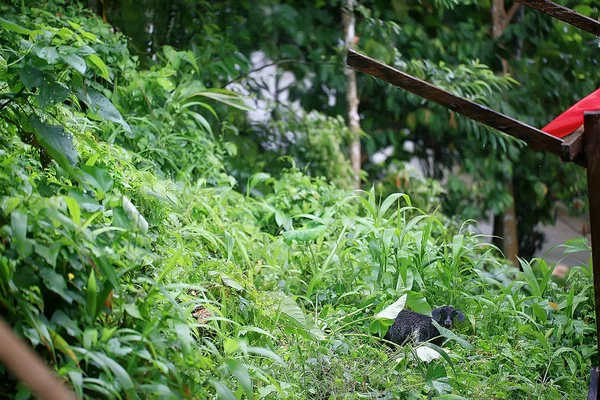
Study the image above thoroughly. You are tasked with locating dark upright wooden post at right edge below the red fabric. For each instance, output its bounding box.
[583,110,600,400]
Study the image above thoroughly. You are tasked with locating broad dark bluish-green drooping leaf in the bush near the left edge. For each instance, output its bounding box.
[29,117,77,175]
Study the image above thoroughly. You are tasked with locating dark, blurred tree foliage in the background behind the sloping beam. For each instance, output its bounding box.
[105,0,600,256]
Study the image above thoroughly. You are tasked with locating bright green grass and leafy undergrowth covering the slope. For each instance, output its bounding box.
[0,1,597,399]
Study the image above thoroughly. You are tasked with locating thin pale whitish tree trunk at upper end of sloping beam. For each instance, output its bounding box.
[343,0,361,188]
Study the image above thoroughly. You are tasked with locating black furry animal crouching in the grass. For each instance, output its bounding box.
[383,306,465,346]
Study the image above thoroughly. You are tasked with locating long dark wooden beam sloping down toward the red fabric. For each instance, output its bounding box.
[347,50,583,165]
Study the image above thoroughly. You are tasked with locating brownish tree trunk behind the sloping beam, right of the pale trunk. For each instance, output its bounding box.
[491,0,521,266]
